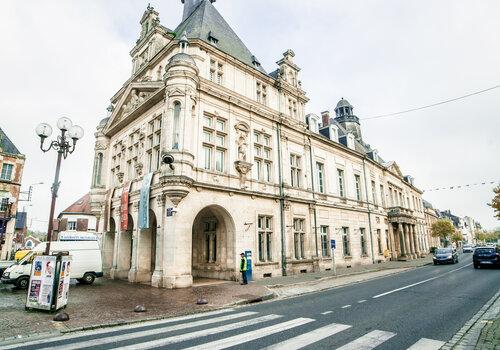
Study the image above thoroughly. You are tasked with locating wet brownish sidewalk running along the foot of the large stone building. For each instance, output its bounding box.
[0,257,432,341]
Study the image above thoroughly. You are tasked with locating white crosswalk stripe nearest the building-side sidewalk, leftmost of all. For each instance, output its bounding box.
[0,309,235,350]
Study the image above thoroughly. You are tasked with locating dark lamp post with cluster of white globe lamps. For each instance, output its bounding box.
[35,117,83,255]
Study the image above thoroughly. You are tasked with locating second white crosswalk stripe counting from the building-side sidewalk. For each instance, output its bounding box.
[38,311,257,350]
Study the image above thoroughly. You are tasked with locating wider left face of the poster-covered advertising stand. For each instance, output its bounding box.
[26,255,56,310]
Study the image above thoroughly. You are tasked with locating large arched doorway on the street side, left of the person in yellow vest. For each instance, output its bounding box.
[191,205,237,280]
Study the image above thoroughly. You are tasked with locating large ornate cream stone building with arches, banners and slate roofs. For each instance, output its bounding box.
[91,0,429,288]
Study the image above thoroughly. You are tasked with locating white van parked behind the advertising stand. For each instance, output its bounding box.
[2,241,102,289]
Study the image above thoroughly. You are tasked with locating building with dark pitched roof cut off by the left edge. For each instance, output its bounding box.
[0,128,25,260]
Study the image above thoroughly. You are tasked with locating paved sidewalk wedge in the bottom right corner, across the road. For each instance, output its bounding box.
[441,292,500,350]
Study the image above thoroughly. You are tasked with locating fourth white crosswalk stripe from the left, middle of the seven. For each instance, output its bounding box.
[184,317,314,350]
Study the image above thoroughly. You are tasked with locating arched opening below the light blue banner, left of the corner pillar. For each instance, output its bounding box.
[137,210,157,282]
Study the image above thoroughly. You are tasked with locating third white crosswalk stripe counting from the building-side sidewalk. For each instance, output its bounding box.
[116,315,283,350]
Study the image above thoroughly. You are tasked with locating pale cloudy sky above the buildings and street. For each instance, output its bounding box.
[0,0,500,230]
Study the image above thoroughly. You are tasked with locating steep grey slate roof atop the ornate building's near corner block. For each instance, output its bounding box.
[174,0,267,74]
